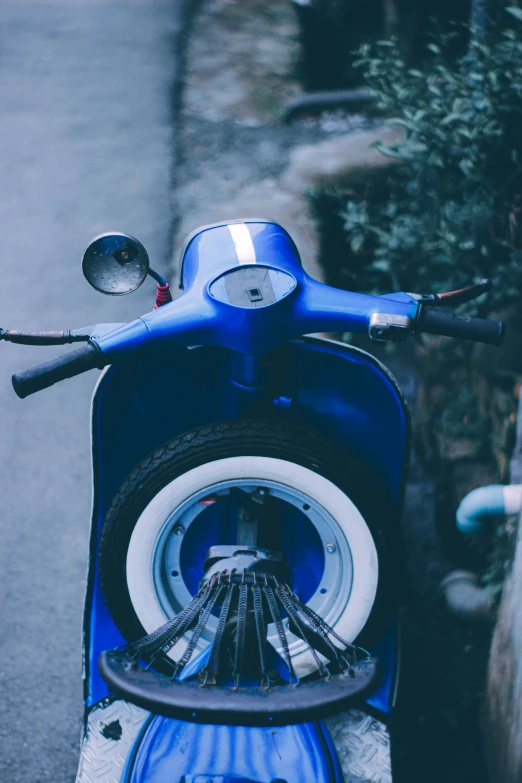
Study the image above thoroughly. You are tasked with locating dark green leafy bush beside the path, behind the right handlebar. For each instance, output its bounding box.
[343,6,522,314]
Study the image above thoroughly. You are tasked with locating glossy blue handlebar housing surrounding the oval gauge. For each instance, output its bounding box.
[95,221,419,363]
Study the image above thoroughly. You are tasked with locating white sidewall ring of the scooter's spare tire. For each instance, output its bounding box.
[126,456,379,676]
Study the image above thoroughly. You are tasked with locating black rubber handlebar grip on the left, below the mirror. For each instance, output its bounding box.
[11,343,105,399]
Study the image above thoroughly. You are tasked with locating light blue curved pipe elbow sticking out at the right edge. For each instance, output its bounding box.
[457,484,522,536]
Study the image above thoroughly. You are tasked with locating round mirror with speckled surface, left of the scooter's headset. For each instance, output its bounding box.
[82,234,149,296]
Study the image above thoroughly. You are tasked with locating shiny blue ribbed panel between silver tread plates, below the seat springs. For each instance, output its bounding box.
[122,715,343,783]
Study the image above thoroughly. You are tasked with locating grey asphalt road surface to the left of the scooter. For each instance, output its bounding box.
[0,0,184,783]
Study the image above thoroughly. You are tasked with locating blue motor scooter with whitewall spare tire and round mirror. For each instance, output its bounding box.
[0,220,503,783]
